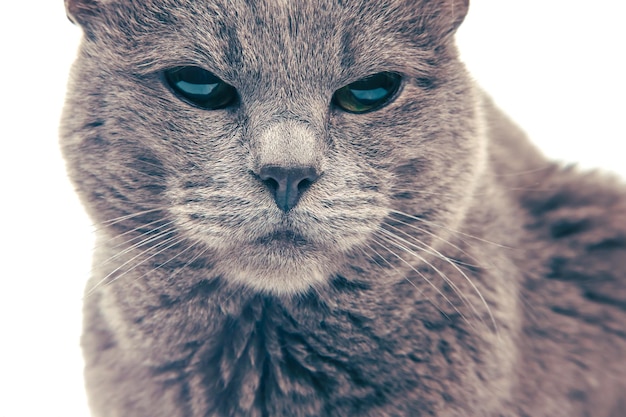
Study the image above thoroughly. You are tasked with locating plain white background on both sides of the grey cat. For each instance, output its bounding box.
[0,0,626,417]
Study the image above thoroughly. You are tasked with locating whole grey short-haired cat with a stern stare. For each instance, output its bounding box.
[61,0,626,417]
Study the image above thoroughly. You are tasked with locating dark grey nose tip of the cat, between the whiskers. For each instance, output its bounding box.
[259,165,319,213]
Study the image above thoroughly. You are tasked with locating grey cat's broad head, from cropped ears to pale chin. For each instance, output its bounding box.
[62,0,485,294]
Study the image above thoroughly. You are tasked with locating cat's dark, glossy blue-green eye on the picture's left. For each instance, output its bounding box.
[164,67,237,110]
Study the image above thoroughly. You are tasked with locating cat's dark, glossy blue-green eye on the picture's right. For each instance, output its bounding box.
[333,72,402,113]
